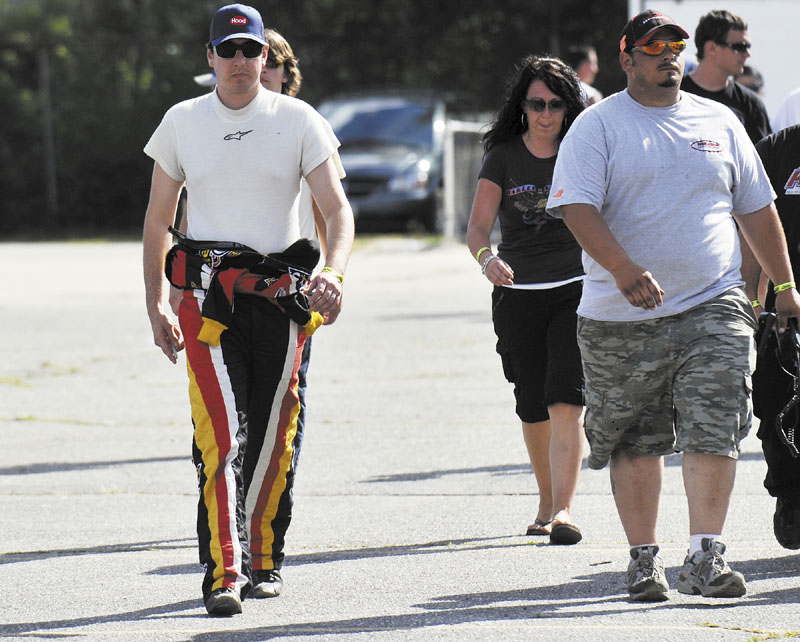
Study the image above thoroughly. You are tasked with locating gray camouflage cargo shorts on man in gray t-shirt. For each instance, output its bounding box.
[578,288,756,469]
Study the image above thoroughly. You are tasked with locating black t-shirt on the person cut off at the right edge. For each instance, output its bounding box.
[756,125,800,305]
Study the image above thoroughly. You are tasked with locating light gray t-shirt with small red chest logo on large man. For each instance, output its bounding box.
[547,90,775,321]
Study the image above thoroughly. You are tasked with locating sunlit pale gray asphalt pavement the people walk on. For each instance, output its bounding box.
[0,237,800,642]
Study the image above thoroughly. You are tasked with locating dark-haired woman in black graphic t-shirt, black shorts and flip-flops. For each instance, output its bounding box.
[467,56,584,544]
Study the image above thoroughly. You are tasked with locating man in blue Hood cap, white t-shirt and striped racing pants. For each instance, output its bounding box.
[143,4,354,616]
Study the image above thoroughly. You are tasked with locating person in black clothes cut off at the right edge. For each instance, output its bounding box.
[753,125,800,549]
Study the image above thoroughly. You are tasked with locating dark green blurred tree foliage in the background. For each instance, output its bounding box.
[0,0,627,237]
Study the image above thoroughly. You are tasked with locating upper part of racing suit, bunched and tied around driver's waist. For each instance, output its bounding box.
[164,227,323,346]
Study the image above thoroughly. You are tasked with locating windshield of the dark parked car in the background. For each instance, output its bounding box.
[320,99,433,149]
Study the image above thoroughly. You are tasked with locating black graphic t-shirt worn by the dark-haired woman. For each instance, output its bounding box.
[478,137,583,284]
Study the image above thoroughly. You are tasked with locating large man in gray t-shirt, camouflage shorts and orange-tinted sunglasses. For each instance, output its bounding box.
[547,10,800,601]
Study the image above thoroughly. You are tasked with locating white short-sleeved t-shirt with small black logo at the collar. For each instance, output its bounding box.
[144,87,341,254]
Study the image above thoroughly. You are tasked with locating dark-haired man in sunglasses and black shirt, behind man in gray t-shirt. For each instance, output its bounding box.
[681,10,772,144]
